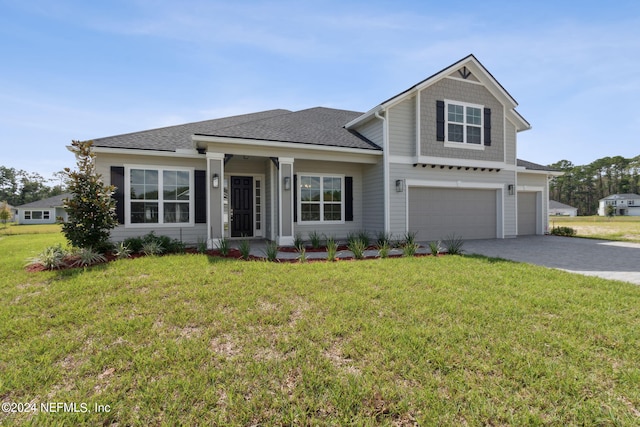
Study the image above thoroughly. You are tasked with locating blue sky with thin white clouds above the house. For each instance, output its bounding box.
[0,0,640,181]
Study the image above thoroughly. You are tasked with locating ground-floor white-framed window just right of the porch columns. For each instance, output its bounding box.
[299,175,344,222]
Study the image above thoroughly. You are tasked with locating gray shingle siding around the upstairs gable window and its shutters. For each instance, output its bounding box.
[420,79,505,162]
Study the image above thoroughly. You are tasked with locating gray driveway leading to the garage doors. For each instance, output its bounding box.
[463,236,640,285]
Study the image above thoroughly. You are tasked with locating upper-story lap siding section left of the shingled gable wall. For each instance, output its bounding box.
[388,97,416,156]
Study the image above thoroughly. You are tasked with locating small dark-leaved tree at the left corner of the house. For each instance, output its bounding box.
[62,141,118,250]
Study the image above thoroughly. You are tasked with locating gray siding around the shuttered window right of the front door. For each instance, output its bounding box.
[293,160,363,240]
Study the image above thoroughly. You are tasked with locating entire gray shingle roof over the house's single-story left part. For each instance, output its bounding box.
[94,107,380,151]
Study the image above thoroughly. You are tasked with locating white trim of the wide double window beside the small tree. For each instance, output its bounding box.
[124,165,196,228]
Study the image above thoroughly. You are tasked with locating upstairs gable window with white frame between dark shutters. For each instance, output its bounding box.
[445,101,483,146]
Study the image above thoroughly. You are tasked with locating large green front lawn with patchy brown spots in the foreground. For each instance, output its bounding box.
[0,234,640,426]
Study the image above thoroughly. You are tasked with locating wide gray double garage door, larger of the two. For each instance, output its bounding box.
[409,187,497,241]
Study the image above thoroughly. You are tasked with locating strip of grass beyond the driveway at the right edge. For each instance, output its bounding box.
[549,216,640,243]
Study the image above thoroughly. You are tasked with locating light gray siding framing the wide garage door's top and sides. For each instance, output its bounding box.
[389,163,516,237]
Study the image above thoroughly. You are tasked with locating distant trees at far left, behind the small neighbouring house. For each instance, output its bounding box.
[0,166,65,206]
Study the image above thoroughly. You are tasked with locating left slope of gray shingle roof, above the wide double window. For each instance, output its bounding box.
[93,110,290,151]
